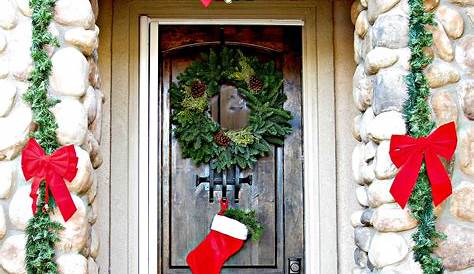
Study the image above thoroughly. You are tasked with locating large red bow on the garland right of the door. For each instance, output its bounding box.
[390,122,457,208]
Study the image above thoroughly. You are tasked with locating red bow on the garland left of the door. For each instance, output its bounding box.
[21,139,78,221]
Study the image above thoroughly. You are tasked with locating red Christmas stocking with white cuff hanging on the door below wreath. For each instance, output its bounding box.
[186,201,248,274]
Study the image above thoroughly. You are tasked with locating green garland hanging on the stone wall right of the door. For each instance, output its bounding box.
[404,0,444,274]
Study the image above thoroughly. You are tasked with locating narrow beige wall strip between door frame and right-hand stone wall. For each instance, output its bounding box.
[334,0,360,274]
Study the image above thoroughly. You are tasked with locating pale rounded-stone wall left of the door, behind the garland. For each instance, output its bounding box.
[0,0,104,274]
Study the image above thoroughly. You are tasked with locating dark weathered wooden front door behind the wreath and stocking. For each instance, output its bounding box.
[156,26,304,274]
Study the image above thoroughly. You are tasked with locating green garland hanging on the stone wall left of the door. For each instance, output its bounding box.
[23,0,62,274]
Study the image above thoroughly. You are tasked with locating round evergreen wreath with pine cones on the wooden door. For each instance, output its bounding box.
[170,48,292,172]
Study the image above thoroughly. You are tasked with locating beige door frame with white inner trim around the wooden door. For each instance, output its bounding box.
[110,0,337,274]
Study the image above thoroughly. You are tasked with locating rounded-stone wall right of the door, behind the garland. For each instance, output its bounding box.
[351,0,474,273]
